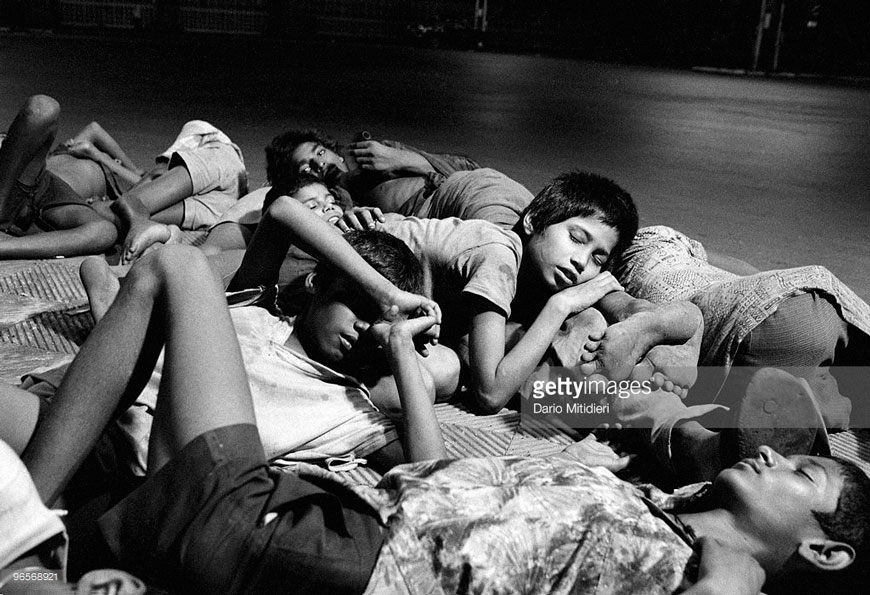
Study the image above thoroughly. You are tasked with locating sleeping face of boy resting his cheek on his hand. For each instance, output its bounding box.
[523,216,619,293]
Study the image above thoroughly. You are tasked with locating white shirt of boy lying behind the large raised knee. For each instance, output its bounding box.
[119,306,398,475]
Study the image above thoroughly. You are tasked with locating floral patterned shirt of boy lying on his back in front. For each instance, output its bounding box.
[342,457,698,595]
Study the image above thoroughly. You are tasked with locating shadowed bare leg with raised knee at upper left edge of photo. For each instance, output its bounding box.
[0,95,60,224]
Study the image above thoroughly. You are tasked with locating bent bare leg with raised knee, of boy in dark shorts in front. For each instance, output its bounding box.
[22,246,255,504]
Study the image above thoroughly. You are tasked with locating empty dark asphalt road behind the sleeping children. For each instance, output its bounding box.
[0,34,870,300]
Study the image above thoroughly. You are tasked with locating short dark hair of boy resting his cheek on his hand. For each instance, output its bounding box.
[516,171,638,264]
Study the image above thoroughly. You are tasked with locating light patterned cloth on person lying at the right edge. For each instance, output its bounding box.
[616,226,870,369]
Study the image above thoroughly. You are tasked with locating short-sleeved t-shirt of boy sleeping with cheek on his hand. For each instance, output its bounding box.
[384,217,522,344]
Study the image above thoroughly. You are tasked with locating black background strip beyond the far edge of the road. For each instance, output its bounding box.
[0,0,870,75]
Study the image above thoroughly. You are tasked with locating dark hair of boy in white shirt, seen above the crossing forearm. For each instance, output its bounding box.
[316,230,424,294]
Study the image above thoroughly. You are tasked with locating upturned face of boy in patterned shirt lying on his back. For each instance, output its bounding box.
[714,446,843,547]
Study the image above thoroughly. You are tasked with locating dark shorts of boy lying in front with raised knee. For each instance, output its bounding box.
[99,424,383,594]
